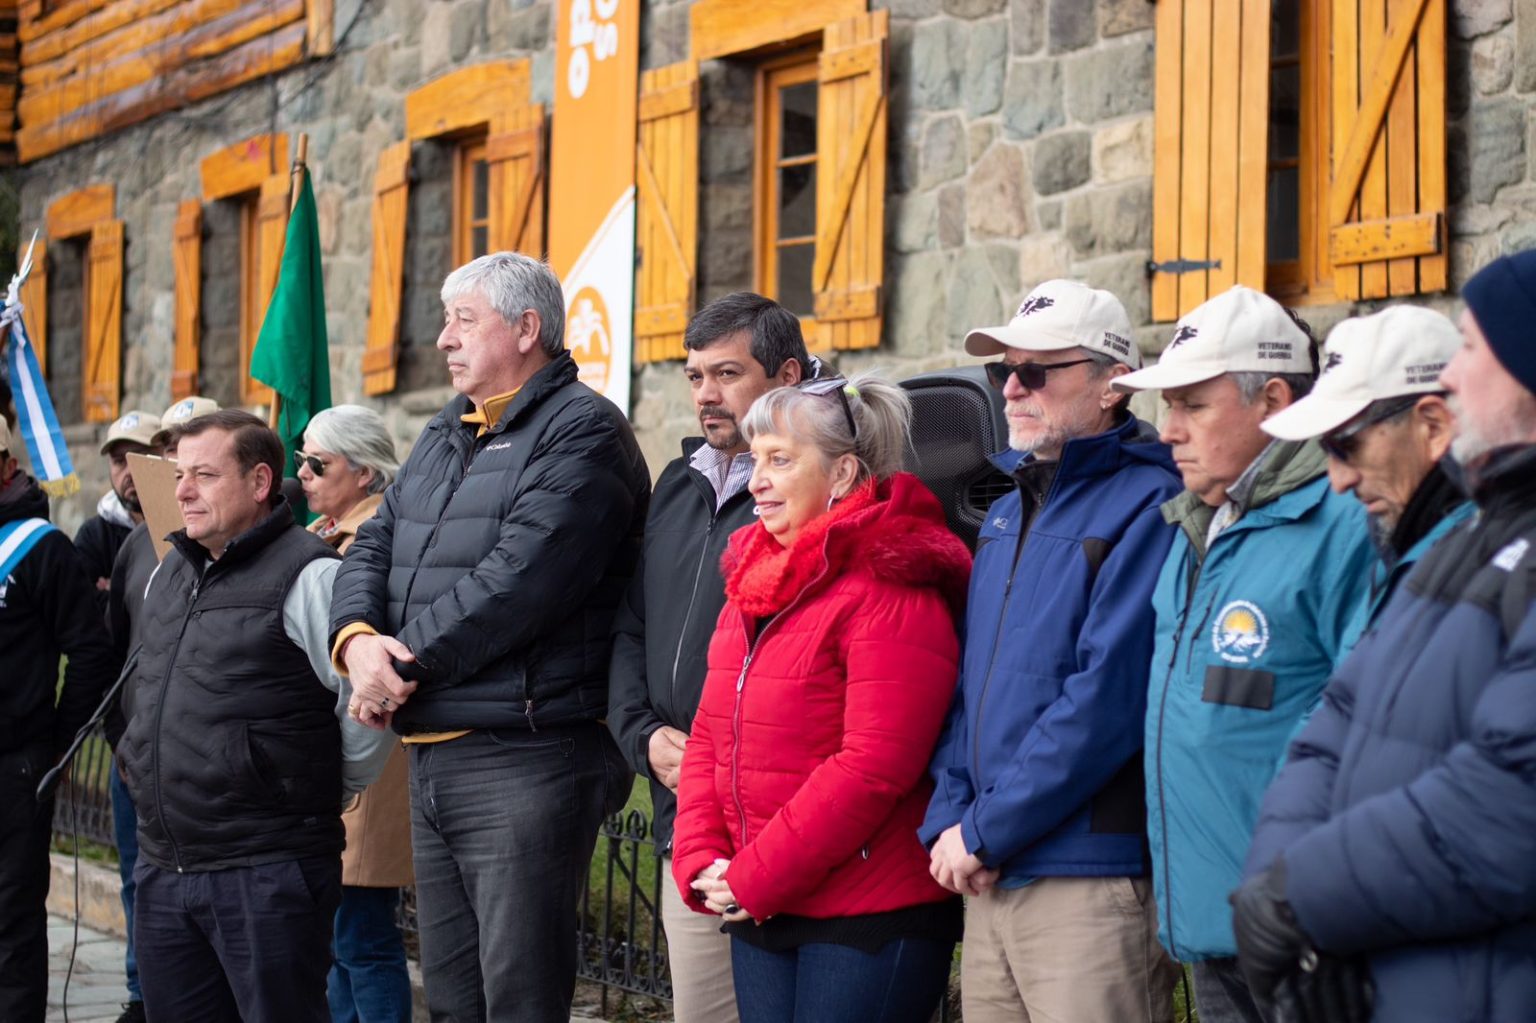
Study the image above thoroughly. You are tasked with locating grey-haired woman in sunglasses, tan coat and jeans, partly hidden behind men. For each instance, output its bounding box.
[293,406,412,1020]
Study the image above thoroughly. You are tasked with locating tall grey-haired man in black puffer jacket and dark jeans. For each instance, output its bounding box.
[330,252,650,1023]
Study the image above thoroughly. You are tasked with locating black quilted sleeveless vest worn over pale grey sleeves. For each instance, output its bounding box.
[118,502,343,871]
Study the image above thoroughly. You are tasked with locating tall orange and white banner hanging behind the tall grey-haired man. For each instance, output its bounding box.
[548,0,641,413]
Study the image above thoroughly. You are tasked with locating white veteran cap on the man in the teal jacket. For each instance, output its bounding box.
[1111,284,1313,392]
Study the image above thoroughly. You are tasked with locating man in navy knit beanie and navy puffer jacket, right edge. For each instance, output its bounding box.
[1235,252,1536,1023]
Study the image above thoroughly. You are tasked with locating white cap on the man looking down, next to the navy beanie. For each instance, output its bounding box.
[1261,306,1461,441]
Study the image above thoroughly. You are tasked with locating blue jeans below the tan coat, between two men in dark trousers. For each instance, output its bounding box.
[326,885,410,1023]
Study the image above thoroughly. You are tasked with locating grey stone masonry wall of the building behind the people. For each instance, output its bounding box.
[9,0,1536,530]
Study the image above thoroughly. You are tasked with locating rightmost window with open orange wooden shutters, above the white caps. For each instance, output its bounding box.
[1149,0,1447,321]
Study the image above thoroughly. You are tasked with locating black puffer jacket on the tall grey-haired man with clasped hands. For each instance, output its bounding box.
[330,353,651,734]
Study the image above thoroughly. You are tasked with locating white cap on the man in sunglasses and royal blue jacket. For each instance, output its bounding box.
[965,280,1141,369]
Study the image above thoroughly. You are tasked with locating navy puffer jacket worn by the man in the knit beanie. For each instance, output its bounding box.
[1247,449,1536,1023]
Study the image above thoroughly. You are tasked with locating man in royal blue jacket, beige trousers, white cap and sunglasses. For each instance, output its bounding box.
[919,281,1180,1023]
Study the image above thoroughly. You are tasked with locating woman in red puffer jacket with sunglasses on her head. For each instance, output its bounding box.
[673,378,971,1023]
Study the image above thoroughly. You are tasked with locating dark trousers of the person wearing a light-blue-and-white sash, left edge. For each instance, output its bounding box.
[0,745,54,1023]
